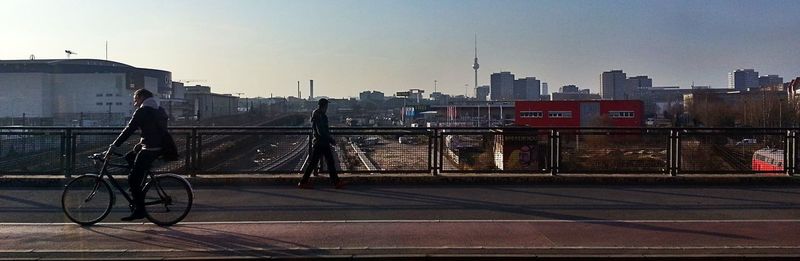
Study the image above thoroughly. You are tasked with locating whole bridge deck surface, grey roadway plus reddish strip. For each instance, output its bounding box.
[0,181,800,260]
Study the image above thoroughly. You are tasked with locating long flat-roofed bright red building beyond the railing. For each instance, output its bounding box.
[514,100,644,127]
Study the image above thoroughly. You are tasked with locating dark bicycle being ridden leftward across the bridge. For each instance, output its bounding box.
[61,149,194,226]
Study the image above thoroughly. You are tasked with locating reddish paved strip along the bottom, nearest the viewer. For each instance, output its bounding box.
[0,220,800,260]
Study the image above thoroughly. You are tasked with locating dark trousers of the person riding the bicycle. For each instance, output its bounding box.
[125,150,161,211]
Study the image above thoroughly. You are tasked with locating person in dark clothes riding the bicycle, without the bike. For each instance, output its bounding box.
[109,89,168,221]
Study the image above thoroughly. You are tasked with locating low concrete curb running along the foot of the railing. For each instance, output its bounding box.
[0,174,800,187]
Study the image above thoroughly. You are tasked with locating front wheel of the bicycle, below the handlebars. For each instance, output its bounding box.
[61,174,114,226]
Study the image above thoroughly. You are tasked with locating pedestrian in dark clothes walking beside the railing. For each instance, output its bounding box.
[297,99,346,189]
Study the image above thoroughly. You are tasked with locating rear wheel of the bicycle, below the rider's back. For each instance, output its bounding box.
[144,174,194,226]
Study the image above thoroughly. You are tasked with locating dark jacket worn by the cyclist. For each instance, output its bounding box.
[114,100,168,150]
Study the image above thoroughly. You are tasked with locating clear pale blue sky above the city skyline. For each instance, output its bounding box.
[0,0,800,97]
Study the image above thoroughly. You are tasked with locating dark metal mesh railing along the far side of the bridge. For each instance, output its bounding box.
[0,127,800,176]
